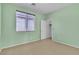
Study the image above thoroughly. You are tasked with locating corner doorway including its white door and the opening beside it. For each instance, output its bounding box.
[41,20,52,40]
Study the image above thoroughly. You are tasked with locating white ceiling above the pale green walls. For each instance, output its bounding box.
[15,3,71,14]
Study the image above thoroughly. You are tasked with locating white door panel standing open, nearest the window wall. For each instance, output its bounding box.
[41,20,47,40]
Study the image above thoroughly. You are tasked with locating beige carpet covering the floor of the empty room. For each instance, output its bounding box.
[1,39,79,55]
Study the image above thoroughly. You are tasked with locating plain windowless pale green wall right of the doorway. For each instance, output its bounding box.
[51,4,79,48]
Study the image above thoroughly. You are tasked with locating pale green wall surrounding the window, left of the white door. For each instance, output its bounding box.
[0,4,44,48]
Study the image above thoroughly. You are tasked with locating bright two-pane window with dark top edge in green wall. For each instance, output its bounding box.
[16,11,35,31]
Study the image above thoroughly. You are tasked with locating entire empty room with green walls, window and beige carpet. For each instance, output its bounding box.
[0,3,79,55]
